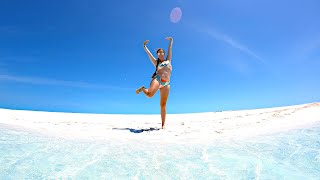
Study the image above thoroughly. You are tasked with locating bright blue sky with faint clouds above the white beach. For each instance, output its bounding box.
[0,0,320,114]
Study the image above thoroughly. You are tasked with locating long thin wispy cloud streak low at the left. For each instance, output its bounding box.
[0,74,134,90]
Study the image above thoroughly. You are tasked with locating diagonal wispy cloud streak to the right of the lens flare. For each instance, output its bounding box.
[191,25,264,63]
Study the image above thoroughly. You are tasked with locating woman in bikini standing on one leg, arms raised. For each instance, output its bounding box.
[136,37,173,129]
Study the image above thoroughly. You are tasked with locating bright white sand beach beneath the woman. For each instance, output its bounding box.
[0,102,320,142]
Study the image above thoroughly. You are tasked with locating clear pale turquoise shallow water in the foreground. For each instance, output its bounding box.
[0,125,320,180]
